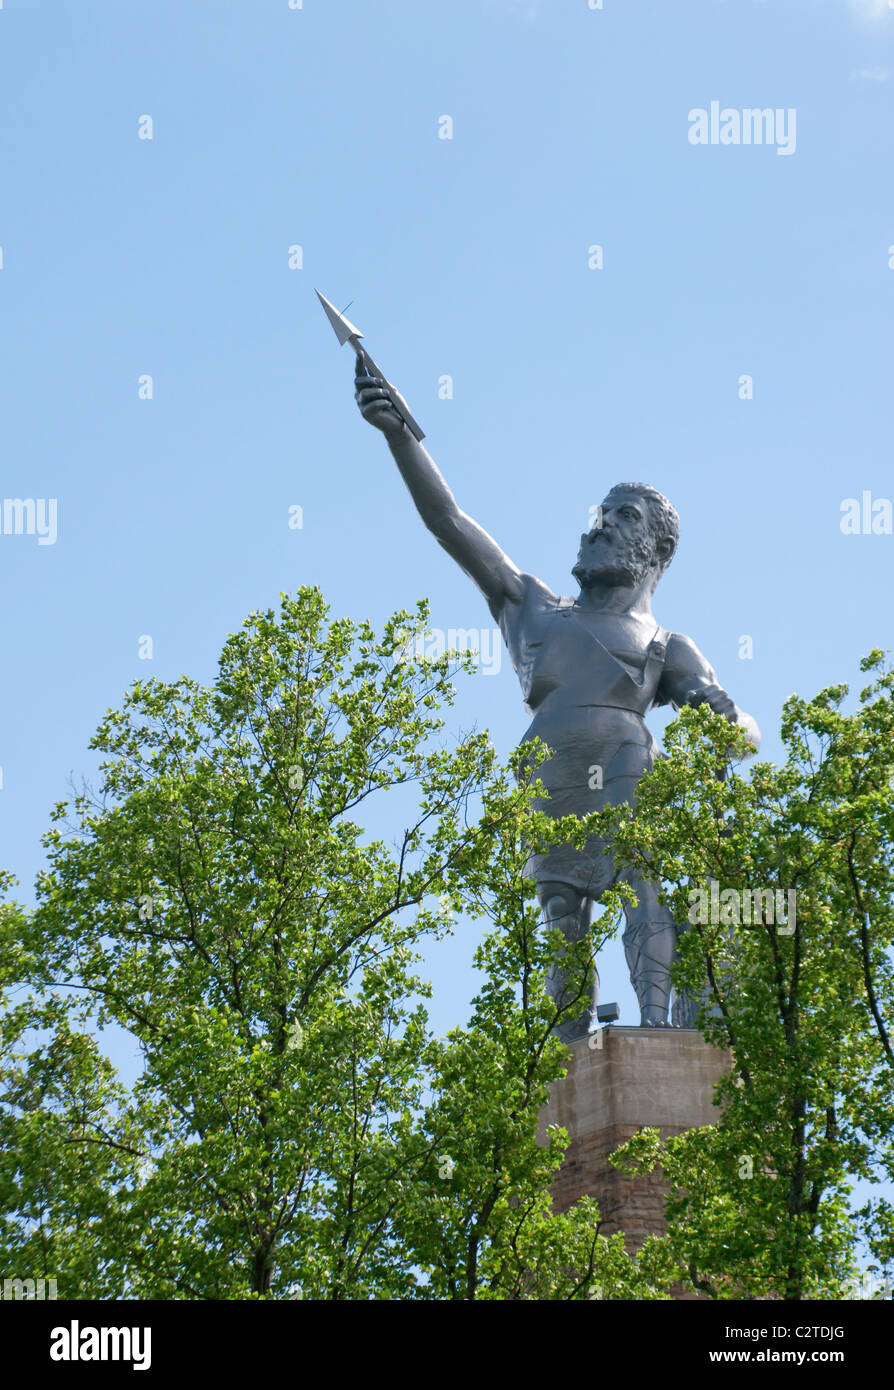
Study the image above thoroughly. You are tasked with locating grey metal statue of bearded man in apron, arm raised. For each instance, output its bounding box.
[355,356,761,1043]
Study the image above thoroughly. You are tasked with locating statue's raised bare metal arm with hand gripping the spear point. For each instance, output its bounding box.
[355,357,521,619]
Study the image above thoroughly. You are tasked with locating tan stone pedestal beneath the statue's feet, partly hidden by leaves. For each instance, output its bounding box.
[541,1024,730,1254]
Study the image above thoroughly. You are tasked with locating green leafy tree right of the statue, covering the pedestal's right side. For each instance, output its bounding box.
[605,652,894,1300]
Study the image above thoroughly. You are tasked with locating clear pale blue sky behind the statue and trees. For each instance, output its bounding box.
[0,0,894,1206]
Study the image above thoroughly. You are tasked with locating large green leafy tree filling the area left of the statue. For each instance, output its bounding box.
[0,589,673,1300]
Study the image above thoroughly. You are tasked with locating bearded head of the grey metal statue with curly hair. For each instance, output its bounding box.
[571,482,680,592]
